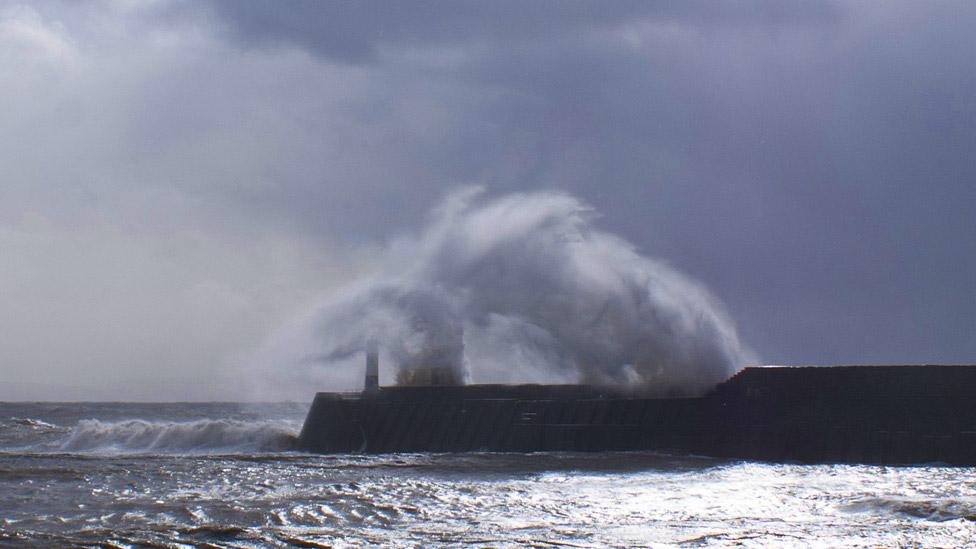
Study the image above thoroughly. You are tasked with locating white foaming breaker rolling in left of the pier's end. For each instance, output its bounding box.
[60,419,295,453]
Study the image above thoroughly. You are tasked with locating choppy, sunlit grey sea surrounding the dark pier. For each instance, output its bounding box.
[0,404,976,547]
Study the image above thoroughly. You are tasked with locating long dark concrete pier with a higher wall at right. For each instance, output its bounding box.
[300,365,976,465]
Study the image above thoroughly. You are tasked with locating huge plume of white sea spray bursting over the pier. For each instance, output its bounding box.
[264,188,747,393]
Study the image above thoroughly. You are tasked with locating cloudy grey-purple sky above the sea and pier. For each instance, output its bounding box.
[0,0,976,400]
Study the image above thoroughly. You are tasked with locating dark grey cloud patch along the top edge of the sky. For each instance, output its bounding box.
[200,0,836,63]
